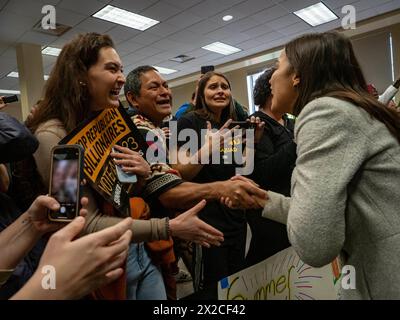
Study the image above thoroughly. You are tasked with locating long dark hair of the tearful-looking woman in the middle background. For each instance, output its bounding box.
[194,71,237,123]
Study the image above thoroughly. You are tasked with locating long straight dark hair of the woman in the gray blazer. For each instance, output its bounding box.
[285,32,400,142]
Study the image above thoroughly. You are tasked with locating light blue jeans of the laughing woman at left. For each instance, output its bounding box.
[126,243,167,300]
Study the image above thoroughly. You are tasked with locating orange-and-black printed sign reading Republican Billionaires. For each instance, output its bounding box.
[59,107,147,212]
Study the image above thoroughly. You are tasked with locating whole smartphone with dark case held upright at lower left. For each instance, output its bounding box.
[48,145,84,221]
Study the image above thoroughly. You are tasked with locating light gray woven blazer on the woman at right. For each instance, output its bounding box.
[263,97,400,299]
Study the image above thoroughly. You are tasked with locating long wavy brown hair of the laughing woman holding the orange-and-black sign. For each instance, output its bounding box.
[26,33,114,132]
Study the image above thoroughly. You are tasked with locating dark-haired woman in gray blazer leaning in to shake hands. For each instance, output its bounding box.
[225,33,400,299]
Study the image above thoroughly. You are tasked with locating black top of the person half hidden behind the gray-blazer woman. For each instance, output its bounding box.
[251,111,296,196]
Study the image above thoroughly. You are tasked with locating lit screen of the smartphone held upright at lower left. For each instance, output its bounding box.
[50,149,79,219]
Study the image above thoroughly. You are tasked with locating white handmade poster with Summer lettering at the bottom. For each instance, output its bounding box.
[218,247,340,300]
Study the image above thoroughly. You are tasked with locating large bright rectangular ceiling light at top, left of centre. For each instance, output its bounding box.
[93,5,160,31]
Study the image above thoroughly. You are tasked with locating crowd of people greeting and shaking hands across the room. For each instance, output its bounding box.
[0,32,400,300]
